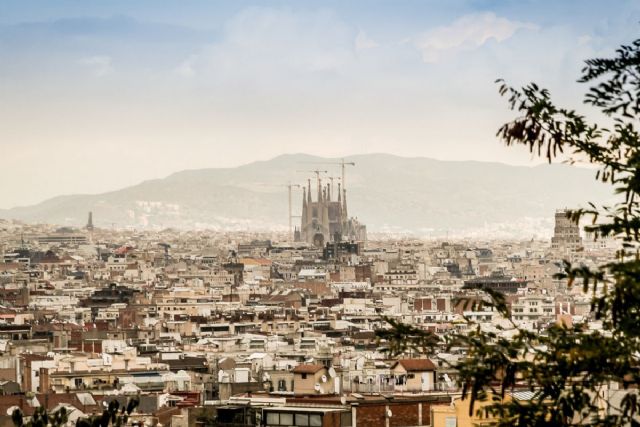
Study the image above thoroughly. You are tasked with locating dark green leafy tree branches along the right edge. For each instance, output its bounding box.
[378,40,640,426]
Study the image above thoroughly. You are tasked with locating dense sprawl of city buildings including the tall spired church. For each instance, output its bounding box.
[0,191,618,427]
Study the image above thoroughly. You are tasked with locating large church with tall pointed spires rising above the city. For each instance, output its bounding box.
[295,177,367,247]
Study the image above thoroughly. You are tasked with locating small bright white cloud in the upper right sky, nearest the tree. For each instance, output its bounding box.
[414,12,537,63]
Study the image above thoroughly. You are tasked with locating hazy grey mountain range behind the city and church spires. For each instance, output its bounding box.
[0,154,612,241]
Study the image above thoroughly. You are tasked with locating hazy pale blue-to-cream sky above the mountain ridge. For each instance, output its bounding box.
[0,0,640,207]
